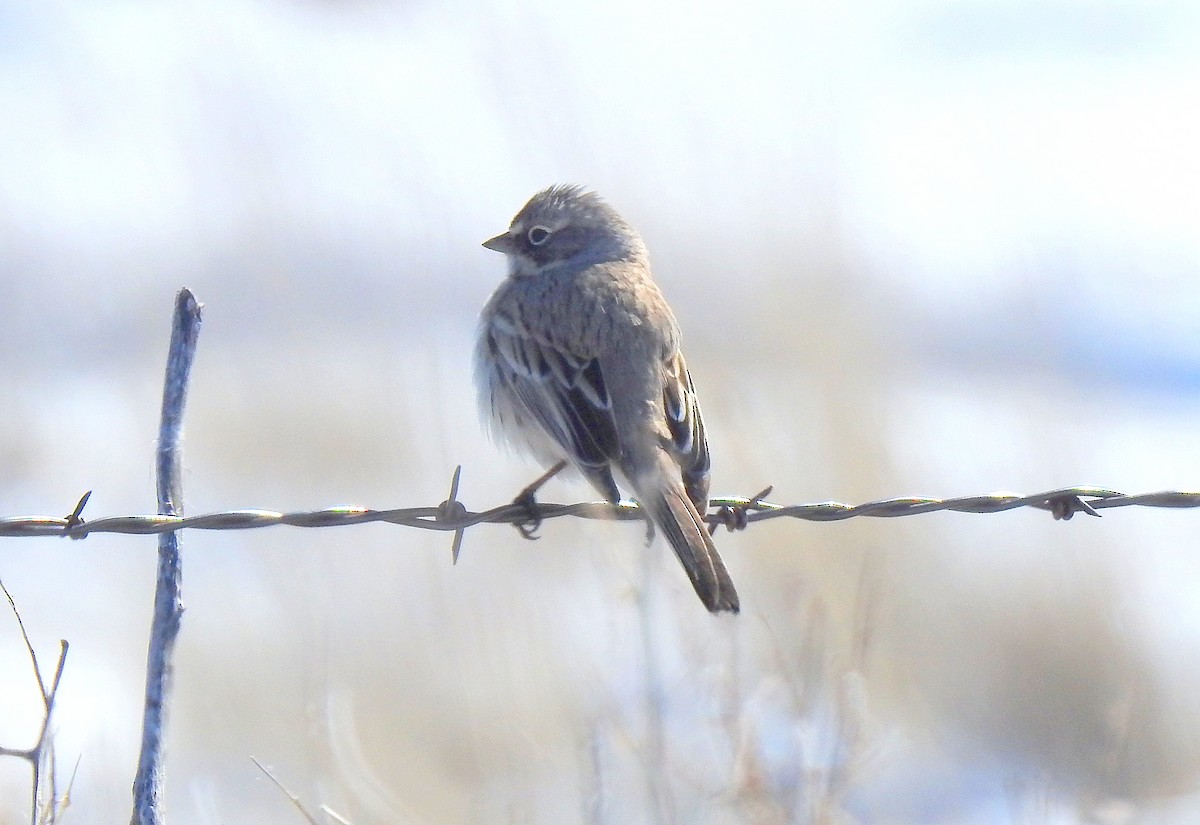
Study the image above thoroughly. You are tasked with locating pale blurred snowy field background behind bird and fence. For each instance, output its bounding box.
[0,0,1200,825]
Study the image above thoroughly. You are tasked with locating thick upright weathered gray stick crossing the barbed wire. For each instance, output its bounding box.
[130,289,200,825]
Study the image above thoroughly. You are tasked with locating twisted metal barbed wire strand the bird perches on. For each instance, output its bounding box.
[0,468,1200,538]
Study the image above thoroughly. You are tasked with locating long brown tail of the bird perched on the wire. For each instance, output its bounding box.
[638,465,740,613]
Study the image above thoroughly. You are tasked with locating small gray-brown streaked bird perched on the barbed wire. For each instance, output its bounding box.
[475,186,738,613]
